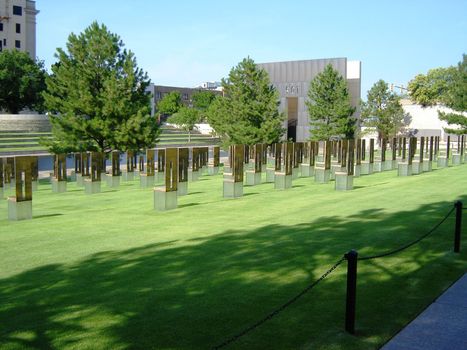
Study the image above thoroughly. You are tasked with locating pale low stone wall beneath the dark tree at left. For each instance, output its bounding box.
[0,114,52,132]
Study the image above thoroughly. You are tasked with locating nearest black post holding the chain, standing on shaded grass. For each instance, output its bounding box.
[345,250,358,334]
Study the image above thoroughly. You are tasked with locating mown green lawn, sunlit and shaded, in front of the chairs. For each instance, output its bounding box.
[0,165,467,349]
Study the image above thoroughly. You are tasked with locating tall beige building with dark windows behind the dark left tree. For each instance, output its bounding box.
[0,0,39,60]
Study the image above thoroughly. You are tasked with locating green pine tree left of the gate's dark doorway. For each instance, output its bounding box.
[207,57,285,146]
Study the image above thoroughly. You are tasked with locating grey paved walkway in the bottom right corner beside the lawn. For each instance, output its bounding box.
[381,273,467,350]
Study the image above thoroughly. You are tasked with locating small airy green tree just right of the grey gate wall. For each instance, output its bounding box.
[361,80,411,138]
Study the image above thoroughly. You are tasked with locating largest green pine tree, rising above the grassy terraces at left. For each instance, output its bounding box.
[44,22,160,152]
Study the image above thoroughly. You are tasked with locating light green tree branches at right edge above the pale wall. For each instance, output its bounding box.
[409,54,467,134]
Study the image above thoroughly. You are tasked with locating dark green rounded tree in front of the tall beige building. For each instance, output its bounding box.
[0,50,46,114]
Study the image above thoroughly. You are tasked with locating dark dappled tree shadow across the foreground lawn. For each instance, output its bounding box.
[0,198,467,349]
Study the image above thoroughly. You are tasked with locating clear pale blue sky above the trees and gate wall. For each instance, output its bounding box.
[36,0,467,97]
